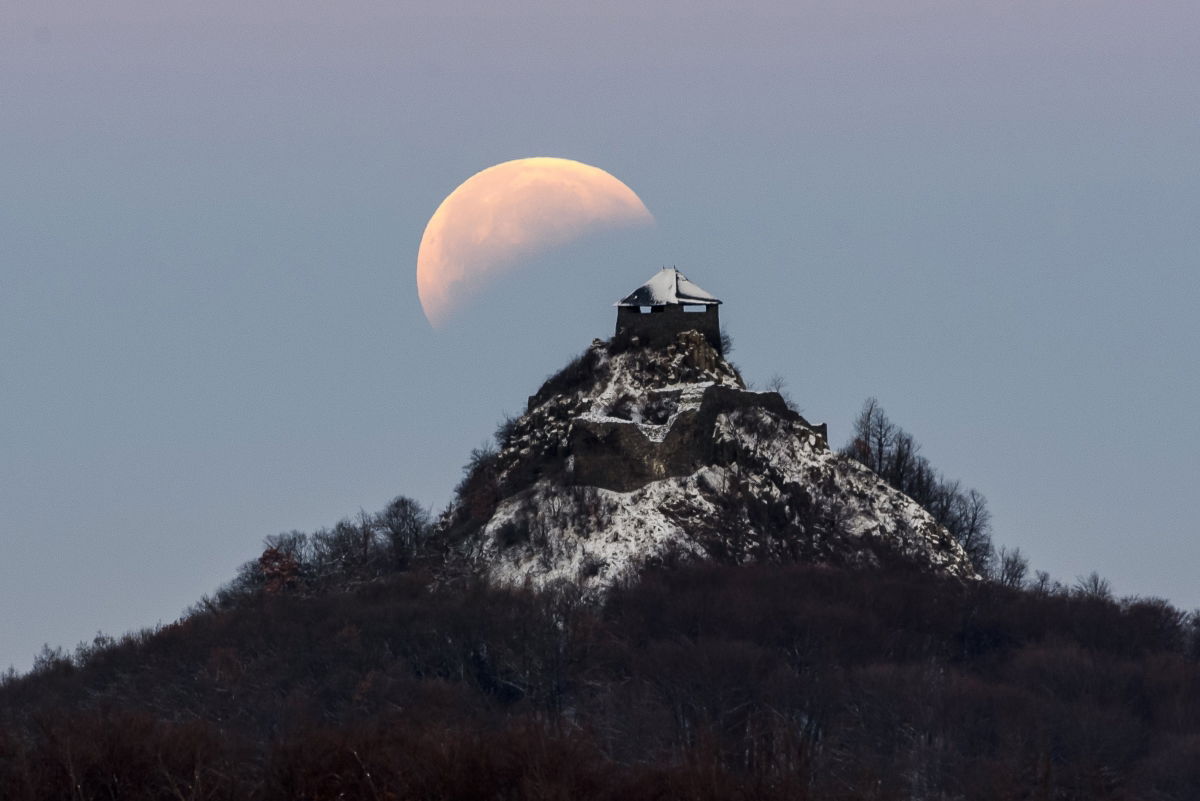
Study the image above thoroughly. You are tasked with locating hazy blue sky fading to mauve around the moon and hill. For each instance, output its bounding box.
[0,0,1200,668]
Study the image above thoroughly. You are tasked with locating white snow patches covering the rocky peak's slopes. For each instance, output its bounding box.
[458,333,974,592]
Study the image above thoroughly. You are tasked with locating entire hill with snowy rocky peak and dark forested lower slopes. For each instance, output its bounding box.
[0,332,1200,801]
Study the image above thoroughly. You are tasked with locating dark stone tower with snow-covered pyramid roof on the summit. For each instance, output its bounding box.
[613,267,721,353]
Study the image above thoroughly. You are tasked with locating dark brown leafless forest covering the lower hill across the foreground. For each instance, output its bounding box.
[0,565,1200,801]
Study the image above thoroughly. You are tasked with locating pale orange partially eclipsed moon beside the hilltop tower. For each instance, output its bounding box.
[416,157,654,327]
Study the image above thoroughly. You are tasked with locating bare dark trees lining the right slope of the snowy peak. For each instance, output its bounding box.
[841,398,998,576]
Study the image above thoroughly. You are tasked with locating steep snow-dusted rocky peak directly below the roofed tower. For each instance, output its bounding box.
[444,331,973,591]
